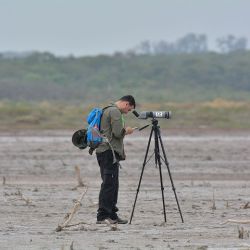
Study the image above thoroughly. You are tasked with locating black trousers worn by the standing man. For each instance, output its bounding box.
[96,150,119,220]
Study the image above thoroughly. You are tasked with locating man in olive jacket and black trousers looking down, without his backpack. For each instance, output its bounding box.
[96,95,135,224]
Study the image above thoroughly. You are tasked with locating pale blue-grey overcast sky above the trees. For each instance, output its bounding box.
[0,0,250,56]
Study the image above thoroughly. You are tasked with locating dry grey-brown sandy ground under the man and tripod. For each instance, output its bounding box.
[0,132,250,250]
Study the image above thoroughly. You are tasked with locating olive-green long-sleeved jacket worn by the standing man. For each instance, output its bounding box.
[96,103,126,160]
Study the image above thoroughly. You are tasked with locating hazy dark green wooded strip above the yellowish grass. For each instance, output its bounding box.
[0,51,250,103]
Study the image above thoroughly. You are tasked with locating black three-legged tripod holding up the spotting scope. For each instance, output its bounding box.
[129,118,184,224]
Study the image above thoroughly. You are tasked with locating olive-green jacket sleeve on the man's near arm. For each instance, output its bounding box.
[110,109,126,138]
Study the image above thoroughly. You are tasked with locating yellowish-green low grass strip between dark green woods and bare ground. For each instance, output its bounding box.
[0,99,250,130]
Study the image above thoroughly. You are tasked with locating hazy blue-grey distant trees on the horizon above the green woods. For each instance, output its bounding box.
[0,33,248,59]
